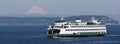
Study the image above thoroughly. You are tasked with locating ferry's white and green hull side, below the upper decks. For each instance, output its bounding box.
[48,28,106,37]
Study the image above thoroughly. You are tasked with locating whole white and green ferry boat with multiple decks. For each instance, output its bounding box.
[47,17,107,37]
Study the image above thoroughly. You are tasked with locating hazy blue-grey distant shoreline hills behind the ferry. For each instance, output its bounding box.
[0,15,119,25]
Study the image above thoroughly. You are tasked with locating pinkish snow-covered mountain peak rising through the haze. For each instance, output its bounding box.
[24,6,47,14]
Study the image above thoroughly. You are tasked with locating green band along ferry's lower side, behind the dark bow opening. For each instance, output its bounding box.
[55,32,106,37]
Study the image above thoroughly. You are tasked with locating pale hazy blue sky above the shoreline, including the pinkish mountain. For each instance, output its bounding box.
[0,0,120,15]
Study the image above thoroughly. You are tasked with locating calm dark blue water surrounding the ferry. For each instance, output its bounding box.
[0,25,120,44]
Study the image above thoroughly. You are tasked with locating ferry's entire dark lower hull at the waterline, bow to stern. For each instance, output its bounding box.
[48,32,106,37]
